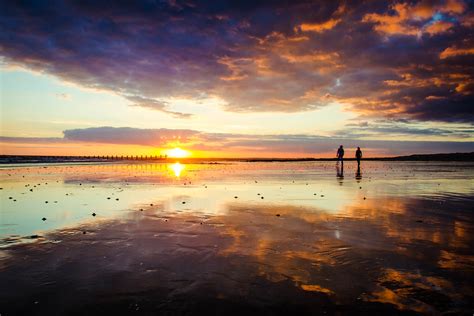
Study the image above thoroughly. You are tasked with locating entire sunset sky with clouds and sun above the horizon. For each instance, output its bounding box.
[0,0,474,158]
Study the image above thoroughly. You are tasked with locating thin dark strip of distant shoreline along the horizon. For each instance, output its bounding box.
[0,152,474,165]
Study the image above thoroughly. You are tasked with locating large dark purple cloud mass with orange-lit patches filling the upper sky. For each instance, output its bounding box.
[0,0,474,123]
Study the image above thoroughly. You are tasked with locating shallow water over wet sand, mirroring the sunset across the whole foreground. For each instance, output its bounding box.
[0,162,474,315]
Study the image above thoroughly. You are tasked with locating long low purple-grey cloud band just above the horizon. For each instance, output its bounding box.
[0,126,474,157]
